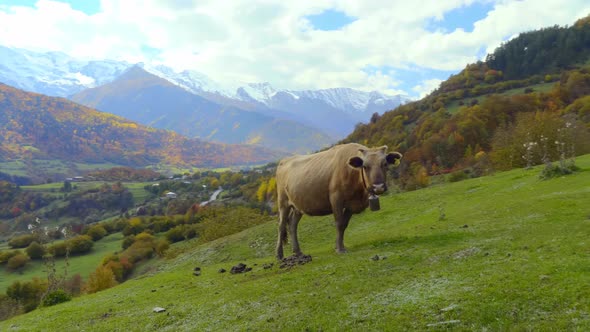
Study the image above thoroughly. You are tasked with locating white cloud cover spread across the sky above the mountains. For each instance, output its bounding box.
[0,0,590,94]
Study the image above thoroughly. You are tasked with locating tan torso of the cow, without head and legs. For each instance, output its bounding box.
[277,144,364,216]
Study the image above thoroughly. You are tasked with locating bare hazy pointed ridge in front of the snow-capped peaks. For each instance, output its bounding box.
[70,66,335,153]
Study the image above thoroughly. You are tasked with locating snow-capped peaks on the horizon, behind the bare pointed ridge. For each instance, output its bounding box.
[0,46,409,139]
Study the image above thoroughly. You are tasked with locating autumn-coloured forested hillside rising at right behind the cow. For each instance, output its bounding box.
[344,17,590,189]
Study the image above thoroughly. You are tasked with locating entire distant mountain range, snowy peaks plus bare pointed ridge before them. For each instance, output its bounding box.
[0,46,408,153]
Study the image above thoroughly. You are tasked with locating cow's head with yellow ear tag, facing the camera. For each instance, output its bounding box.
[348,145,402,195]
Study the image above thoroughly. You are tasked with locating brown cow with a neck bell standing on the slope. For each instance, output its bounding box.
[276,143,402,260]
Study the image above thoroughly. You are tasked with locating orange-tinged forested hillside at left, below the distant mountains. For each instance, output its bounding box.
[0,84,278,166]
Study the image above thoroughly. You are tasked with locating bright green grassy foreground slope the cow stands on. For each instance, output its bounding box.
[0,156,590,331]
